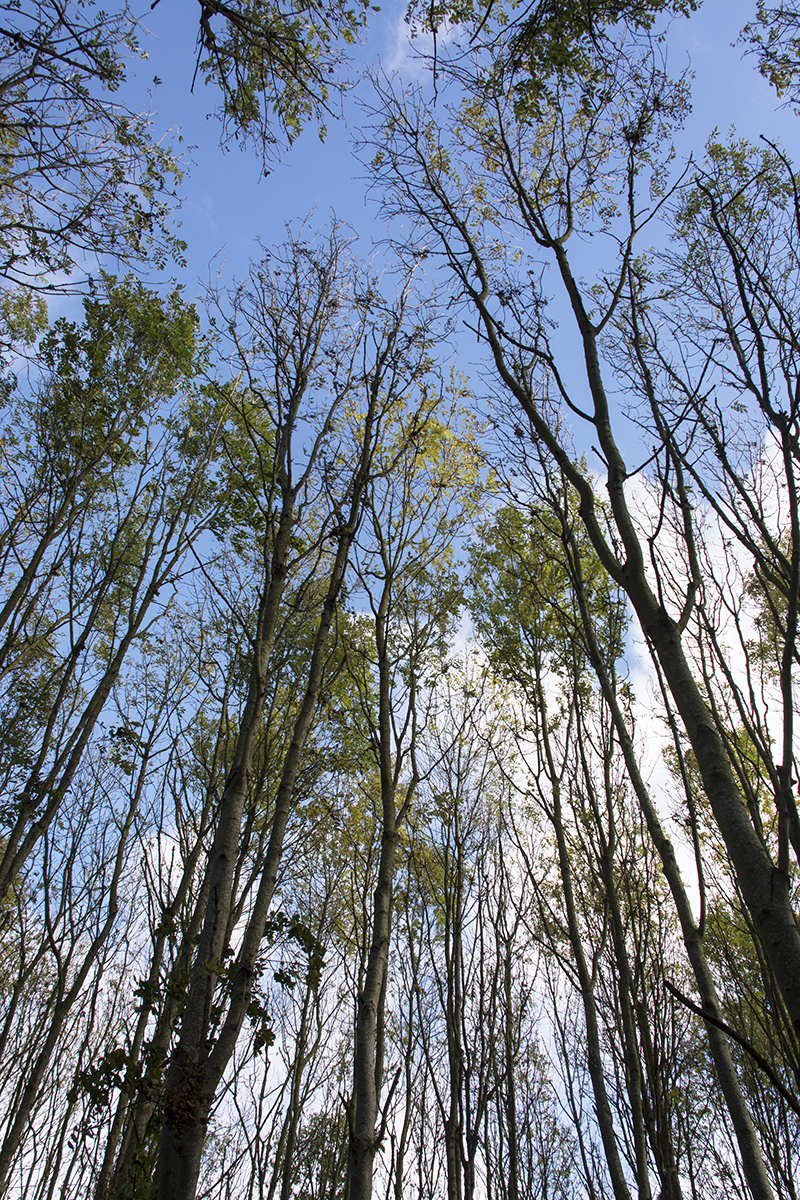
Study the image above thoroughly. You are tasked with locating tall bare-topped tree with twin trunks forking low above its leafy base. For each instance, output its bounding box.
[153,226,450,1200]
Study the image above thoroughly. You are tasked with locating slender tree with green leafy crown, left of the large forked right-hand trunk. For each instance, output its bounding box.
[473,520,650,1200]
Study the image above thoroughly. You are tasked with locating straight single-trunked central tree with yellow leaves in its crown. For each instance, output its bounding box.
[338,371,480,1200]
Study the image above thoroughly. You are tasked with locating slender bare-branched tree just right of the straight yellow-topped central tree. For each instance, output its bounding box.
[419,700,506,1200]
